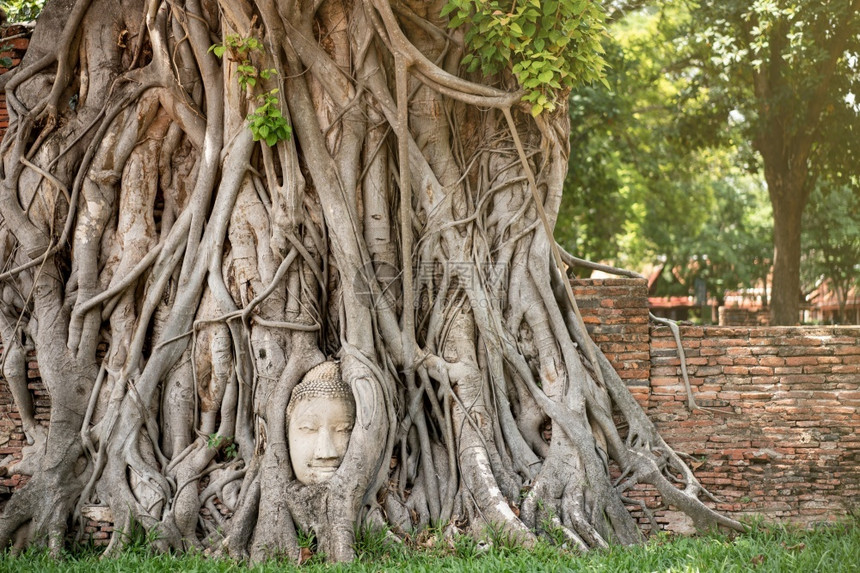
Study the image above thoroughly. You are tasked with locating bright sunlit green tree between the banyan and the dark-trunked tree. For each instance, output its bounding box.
[557,5,772,312]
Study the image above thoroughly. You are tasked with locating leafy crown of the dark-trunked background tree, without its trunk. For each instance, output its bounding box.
[671,0,860,175]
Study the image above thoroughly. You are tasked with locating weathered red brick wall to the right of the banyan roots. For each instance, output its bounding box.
[574,279,860,530]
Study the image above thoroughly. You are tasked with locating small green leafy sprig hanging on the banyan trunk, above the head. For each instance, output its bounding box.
[209,34,292,147]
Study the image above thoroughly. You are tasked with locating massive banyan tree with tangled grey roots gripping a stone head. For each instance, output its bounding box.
[0,0,739,560]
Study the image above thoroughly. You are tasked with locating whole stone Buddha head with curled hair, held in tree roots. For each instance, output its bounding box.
[287,362,355,485]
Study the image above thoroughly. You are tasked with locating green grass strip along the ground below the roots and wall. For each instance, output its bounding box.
[0,519,860,573]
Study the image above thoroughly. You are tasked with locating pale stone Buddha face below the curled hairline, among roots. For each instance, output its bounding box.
[287,396,355,484]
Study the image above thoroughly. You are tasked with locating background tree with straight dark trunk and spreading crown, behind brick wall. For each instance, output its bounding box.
[676,0,860,325]
